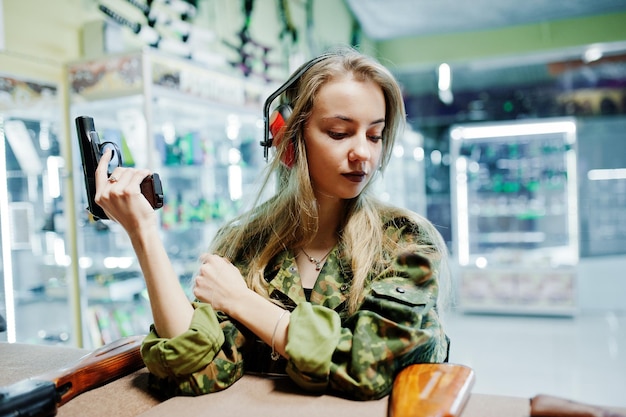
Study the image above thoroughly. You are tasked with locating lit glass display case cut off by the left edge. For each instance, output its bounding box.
[0,74,76,344]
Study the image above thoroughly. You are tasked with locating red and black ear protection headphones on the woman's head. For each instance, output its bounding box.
[261,54,334,168]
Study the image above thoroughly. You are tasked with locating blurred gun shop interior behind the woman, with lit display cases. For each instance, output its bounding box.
[0,0,626,407]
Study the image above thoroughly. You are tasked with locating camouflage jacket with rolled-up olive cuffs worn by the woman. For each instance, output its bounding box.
[142,214,448,400]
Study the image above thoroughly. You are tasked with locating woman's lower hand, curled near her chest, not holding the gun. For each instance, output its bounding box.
[193,254,249,315]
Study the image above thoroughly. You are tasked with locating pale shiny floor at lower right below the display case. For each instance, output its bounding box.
[446,310,626,407]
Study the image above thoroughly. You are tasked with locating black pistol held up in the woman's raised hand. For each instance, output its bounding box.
[76,116,163,219]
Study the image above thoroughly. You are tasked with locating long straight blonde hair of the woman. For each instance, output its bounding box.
[212,48,446,312]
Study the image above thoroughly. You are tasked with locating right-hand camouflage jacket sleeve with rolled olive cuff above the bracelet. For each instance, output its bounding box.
[286,277,448,400]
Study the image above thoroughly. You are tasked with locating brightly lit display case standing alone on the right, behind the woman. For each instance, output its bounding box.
[450,118,579,315]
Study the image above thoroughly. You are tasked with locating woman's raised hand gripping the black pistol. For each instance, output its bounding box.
[95,149,158,233]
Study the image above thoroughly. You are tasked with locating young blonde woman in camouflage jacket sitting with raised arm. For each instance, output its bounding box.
[96,48,448,400]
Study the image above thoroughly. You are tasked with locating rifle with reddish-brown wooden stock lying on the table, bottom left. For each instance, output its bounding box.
[0,336,145,417]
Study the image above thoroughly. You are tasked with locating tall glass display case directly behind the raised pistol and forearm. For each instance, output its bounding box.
[68,51,267,346]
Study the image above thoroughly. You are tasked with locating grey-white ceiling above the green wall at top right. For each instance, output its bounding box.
[346,0,626,40]
